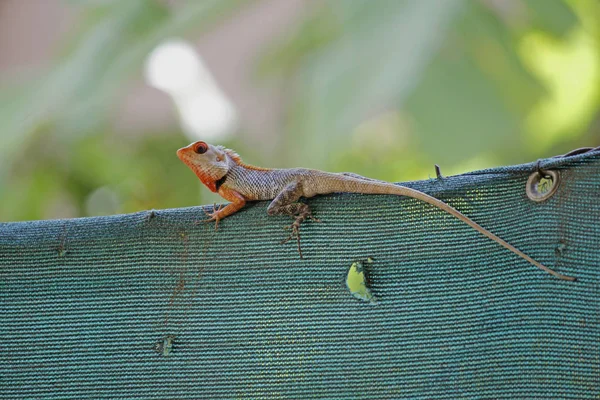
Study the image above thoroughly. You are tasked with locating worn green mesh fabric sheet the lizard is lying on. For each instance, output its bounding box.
[0,152,600,400]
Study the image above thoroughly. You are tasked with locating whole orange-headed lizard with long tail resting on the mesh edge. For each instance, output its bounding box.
[177,141,576,281]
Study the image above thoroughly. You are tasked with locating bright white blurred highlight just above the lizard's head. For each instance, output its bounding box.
[145,39,238,141]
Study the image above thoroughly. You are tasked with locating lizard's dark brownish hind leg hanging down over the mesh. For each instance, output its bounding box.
[267,181,318,258]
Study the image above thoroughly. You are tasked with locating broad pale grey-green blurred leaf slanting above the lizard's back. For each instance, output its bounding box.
[292,0,462,163]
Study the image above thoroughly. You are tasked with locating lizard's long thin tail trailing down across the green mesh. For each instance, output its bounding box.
[340,176,577,281]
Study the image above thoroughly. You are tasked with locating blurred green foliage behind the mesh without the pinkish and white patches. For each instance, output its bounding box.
[0,0,600,221]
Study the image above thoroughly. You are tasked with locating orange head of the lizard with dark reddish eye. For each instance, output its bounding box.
[177,141,229,192]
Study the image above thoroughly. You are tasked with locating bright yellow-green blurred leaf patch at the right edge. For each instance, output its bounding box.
[520,1,600,151]
